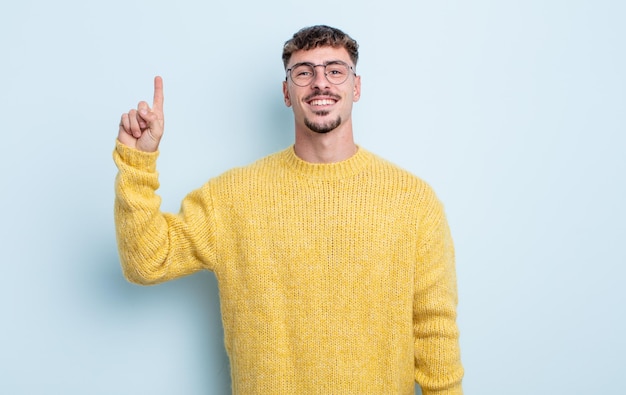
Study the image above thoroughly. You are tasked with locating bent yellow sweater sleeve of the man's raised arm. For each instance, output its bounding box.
[113,141,215,285]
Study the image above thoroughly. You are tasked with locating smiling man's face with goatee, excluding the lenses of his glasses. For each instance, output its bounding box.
[283,47,361,133]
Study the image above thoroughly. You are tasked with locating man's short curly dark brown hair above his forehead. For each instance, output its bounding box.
[283,25,359,69]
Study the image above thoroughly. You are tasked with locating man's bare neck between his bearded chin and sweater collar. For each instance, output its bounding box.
[294,125,357,163]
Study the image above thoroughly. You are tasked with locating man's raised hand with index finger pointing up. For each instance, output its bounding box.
[117,77,165,152]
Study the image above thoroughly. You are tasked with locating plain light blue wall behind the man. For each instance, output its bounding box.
[0,0,626,395]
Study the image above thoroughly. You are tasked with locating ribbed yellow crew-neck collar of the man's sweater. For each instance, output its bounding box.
[281,146,372,179]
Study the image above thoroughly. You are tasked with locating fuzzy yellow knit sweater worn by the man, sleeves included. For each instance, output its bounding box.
[114,141,463,395]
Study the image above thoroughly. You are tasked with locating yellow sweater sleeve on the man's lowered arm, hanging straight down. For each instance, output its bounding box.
[413,188,463,395]
